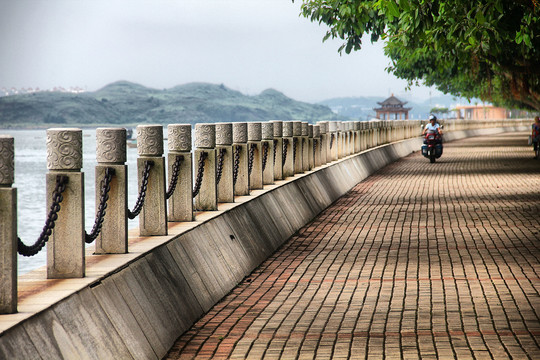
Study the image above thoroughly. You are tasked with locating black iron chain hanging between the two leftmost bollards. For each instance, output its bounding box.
[17,175,69,256]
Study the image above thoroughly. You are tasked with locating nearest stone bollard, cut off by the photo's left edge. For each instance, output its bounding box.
[0,135,17,314]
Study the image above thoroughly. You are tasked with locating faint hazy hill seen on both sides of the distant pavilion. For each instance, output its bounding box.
[319,95,468,120]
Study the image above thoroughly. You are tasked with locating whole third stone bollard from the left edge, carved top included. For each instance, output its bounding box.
[95,128,128,254]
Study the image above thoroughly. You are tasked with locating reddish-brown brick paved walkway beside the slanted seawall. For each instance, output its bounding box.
[168,133,540,359]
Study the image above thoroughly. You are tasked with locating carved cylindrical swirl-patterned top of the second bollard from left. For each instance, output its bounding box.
[47,128,82,171]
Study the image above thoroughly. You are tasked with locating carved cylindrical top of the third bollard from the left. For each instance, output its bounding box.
[96,128,127,164]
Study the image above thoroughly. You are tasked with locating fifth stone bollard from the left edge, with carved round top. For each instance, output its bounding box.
[167,124,193,221]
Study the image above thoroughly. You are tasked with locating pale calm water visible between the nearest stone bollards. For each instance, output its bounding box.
[0,130,146,274]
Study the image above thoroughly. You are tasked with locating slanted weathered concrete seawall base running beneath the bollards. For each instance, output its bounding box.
[0,128,527,359]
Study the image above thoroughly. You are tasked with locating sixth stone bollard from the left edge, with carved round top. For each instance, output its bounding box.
[193,124,217,211]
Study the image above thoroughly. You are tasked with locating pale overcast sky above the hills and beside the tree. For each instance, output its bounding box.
[0,0,439,102]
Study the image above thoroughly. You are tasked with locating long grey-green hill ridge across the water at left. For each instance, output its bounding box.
[0,81,346,128]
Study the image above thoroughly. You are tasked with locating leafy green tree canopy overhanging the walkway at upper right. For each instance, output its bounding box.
[293,0,540,110]
